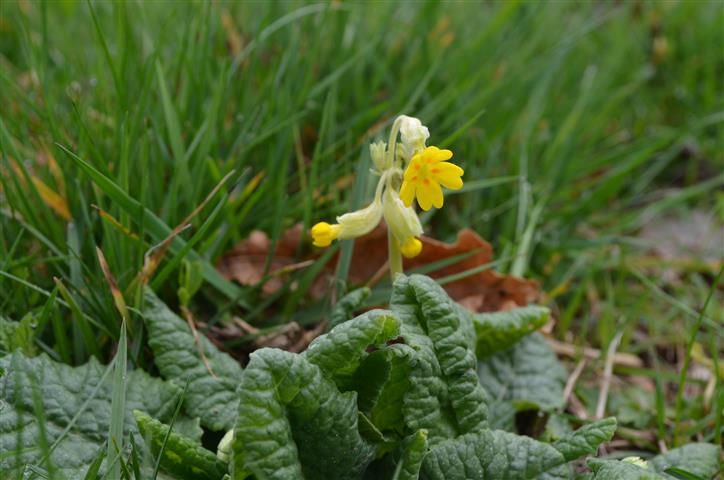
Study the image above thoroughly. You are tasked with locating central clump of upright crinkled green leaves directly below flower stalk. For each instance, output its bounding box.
[233,275,615,480]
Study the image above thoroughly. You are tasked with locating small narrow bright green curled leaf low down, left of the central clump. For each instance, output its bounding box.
[133,410,227,480]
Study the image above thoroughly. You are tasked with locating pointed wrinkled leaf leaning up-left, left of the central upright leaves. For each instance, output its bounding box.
[144,289,242,431]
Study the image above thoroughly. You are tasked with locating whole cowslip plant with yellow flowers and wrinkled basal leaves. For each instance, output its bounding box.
[0,116,719,480]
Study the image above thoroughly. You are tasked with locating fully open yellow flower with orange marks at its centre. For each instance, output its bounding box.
[400,147,464,210]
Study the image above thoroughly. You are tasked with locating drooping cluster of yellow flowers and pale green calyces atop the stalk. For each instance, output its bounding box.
[311,115,464,258]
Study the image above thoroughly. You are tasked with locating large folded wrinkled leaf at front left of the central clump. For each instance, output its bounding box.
[232,348,375,480]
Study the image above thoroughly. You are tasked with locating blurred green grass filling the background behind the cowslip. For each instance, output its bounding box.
[0,1,724,448]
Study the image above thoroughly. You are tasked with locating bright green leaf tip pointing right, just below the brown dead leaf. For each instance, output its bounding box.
[472,305,550,358]
